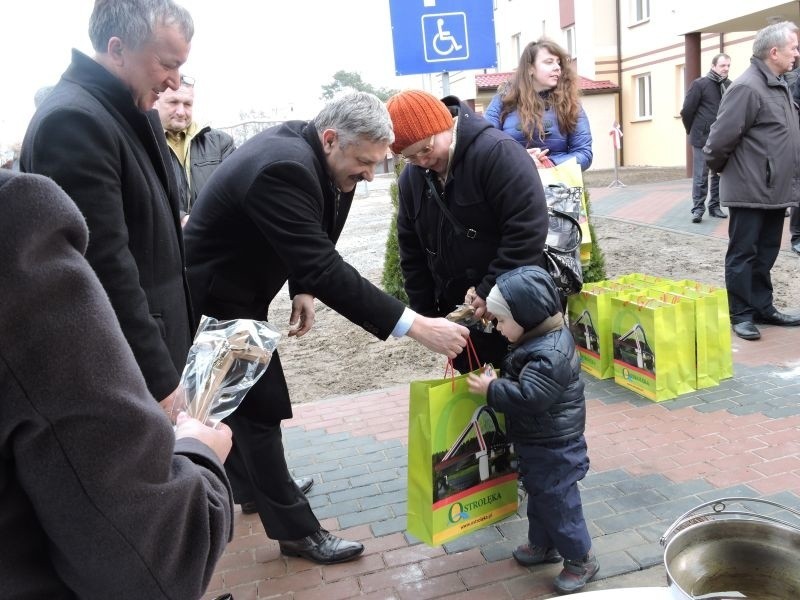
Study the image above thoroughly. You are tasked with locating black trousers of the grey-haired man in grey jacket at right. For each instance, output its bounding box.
[725,207,786,323]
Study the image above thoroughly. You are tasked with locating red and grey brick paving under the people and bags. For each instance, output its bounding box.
[205,180,800,600]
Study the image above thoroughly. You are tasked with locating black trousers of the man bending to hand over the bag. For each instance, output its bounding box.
[225,412,320,540]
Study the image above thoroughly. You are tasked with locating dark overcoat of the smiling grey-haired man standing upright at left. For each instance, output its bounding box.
[21,50,192,400]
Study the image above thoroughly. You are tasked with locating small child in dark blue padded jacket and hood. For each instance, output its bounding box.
[469,267,600,594]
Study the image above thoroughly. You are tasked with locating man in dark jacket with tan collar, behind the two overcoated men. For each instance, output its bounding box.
[155,76,236,223]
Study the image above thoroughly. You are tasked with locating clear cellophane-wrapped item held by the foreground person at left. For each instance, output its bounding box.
[181,315,280,425]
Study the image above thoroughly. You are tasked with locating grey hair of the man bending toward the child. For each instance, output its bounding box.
[311,92,394,148]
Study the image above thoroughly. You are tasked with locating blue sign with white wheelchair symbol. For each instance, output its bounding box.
[389,0,497,75]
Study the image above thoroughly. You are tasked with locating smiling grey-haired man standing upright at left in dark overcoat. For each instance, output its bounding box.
[22,0,194,412]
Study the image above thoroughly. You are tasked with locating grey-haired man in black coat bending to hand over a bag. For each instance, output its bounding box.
[184,93,468,563]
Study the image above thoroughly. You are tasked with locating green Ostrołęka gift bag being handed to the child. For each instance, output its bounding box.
[407,375,517,546]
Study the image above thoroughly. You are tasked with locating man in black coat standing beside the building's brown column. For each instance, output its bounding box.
[681,54,731,223]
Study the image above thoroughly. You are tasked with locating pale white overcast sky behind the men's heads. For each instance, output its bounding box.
[0,0,432,146]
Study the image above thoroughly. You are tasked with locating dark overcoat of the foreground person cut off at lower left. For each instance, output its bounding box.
[0,170,233,600]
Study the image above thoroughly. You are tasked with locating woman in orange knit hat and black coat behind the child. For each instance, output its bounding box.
[386,90,548,372]
